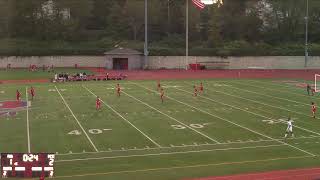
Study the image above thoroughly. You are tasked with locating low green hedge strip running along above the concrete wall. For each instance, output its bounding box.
[0,39,320,56]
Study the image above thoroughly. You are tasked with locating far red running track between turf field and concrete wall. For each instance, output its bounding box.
[0,67,320,84]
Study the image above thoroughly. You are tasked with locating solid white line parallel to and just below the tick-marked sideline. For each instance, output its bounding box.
[56,144,287,163]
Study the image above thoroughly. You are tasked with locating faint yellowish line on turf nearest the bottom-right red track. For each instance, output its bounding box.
[51,156,313,179]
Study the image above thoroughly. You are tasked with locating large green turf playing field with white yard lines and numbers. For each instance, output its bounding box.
[0,80,320,180]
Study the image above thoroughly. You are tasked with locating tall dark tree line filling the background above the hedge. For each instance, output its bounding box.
[0,0,320,55]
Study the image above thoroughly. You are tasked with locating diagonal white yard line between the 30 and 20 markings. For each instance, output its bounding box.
[133,83,316,156]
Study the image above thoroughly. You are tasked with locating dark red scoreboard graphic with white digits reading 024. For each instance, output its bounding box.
[0,153,55,178]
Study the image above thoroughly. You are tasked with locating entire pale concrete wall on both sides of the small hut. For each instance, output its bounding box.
[0,56,320,69]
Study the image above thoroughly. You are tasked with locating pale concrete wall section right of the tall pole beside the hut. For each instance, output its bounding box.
[148,56,320,69]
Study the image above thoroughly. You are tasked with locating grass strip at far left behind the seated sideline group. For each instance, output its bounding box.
[0,67,92,80]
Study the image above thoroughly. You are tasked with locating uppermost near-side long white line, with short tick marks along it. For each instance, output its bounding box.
[56,136,320,156]
